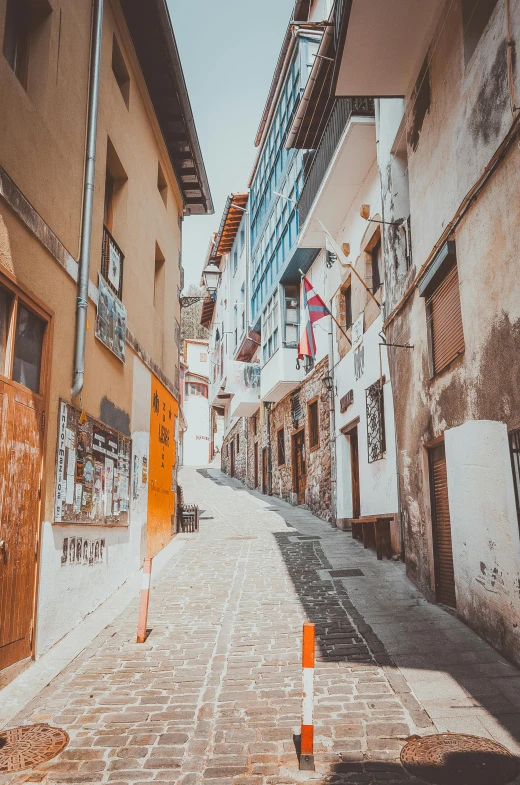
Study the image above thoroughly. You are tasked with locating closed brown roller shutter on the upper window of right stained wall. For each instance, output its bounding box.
[428,266,464,373]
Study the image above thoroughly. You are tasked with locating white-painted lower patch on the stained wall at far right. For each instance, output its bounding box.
[445,420,520,664]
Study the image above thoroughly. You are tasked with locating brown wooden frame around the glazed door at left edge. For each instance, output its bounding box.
[0,264,55,659]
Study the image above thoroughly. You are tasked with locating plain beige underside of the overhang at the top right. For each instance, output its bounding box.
[334,0,445,98]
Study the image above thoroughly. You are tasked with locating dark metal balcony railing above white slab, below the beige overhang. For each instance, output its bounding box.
[298,98,374,227]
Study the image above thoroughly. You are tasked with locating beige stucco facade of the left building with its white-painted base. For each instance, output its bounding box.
[0,0,186,652]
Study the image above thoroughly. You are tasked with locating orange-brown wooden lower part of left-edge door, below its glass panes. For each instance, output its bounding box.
[0,381,43,670]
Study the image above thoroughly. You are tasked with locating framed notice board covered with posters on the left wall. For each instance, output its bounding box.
[54,401,131,526]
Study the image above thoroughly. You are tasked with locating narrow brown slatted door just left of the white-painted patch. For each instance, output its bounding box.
[430,443,457,608]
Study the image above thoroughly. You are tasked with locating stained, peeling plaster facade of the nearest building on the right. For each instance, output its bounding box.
[378,2,520,656]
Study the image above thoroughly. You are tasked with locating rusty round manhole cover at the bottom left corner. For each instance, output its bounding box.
[0,724,69,772]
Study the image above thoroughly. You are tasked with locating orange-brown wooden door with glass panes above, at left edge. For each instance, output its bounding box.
[0,279,48,670]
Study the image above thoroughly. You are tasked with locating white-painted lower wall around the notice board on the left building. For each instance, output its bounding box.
[36,356,151,657]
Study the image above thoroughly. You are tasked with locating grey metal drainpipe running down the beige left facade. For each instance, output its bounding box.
[71,0,103,398]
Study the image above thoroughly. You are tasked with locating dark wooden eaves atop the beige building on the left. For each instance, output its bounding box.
[121,0,213,215]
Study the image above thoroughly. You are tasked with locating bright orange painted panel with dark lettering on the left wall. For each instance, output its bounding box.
[148,376,179,556]
